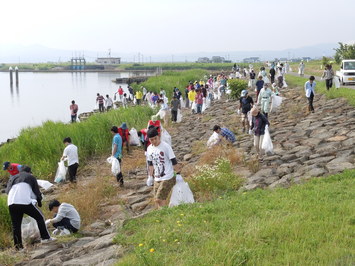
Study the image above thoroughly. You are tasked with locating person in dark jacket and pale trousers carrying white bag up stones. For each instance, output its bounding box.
[250,107,270,161]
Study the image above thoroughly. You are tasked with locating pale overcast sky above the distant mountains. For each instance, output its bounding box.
[0,0,355,54]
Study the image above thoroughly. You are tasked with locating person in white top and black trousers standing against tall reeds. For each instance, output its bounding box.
[61,137,79,183]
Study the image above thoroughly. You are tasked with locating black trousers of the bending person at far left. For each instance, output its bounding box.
[9,204,50,249]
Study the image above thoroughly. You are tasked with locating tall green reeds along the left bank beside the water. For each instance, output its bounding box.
[0,106,153,180]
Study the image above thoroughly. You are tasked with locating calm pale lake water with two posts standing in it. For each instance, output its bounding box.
[0,72,145,143]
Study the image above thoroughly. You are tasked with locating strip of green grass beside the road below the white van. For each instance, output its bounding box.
[286,75,355,106]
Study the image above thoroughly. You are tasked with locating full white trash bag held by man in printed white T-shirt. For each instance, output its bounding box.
[169,175,195,207]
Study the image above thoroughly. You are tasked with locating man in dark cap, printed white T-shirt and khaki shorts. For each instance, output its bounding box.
[147,128,179,208]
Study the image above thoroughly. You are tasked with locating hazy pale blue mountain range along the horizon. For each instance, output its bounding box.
[0,43,338,64]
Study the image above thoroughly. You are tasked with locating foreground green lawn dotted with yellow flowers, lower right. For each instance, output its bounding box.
[116,170,355,265]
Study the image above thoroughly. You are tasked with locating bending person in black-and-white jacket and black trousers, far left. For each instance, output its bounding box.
[6,166,56,250]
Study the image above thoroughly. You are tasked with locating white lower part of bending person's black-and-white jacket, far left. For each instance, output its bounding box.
[7,182,37,206]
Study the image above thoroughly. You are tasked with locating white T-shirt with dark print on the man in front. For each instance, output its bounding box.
[147,141,175,181]
